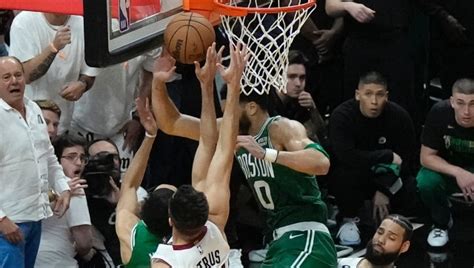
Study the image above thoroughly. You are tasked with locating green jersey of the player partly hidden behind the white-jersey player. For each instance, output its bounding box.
[125,221,164,268]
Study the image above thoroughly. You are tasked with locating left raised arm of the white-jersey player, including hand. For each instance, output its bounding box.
[192,43,223,189]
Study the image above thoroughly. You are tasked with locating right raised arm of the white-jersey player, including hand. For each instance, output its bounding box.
[204,44,248,231]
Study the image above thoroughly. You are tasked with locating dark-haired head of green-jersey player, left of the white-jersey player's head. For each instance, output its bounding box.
[140,188,174,238]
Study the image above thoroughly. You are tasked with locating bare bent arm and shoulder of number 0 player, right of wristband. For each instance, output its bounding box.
[269,118,330,175]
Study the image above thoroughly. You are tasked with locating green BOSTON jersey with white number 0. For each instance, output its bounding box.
[236,116,327,230]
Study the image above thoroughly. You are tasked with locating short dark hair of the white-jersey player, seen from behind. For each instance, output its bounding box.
[169,185,209,236]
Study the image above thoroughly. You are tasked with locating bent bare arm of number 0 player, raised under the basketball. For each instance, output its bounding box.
[152,48,199,140]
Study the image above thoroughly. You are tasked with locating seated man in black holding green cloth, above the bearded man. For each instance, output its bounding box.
[329,72,416,245]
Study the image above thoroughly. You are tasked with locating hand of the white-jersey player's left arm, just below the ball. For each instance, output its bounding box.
[194,42,224,89]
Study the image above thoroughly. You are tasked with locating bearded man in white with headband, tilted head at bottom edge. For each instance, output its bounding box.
[338,214,413,268]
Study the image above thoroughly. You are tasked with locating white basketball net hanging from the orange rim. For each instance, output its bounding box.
[220,0,315,95]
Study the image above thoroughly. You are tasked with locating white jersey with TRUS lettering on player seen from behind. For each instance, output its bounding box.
[152,221,230,268]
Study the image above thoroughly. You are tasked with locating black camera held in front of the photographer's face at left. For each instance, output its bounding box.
[83,153,120,196]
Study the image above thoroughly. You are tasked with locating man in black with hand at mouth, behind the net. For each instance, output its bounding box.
[271,50,327,142]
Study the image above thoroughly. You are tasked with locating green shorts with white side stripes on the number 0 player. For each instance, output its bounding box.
[261,230,337,268]
